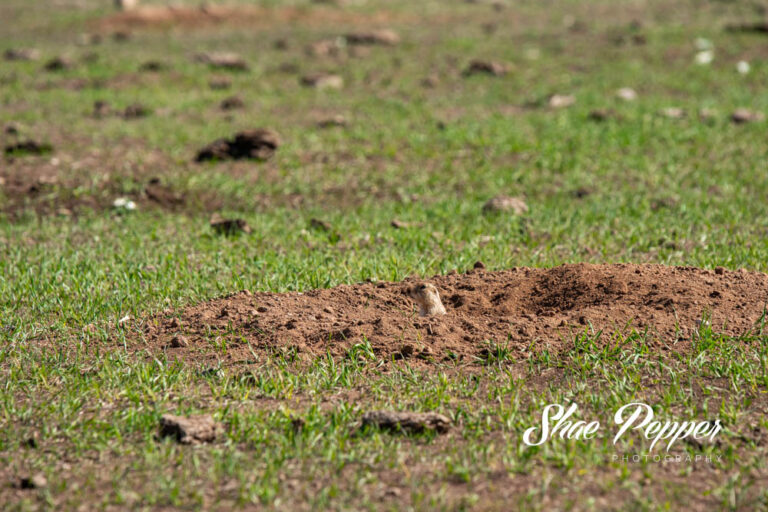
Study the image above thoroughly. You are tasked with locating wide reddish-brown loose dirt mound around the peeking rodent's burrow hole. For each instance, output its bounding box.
[145,264,768,364]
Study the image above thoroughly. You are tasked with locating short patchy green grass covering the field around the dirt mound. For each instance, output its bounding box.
[0,0,768,510]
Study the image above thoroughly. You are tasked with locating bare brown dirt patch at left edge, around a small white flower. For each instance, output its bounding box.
[0,135,225,220]
